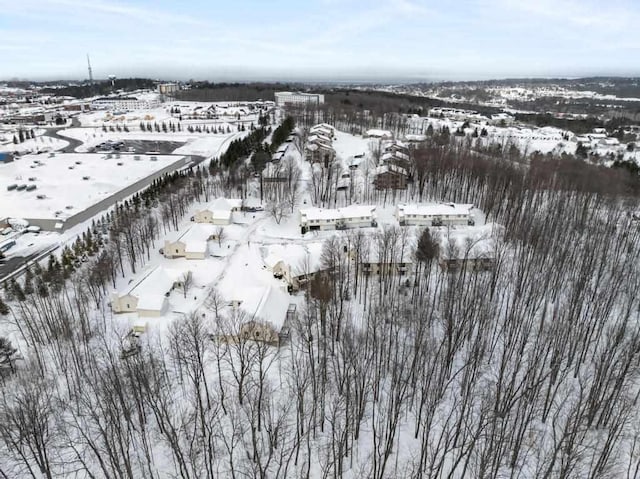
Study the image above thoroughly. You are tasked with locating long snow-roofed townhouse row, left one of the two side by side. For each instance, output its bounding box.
[300,205,378,234]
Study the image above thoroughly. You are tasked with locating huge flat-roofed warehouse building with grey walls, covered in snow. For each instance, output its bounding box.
[0,153,190,232]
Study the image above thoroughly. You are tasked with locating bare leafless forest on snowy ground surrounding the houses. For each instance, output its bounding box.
[0,118,640,479]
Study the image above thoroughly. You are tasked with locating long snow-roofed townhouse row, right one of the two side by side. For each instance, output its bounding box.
[396,203,473,226]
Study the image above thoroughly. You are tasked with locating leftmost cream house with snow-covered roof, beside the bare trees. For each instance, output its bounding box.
[111,266,189,317]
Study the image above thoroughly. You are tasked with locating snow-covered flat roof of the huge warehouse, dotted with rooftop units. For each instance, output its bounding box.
[0,153,185,218]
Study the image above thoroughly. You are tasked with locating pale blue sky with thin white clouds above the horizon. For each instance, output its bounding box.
[0,0,640,81]
